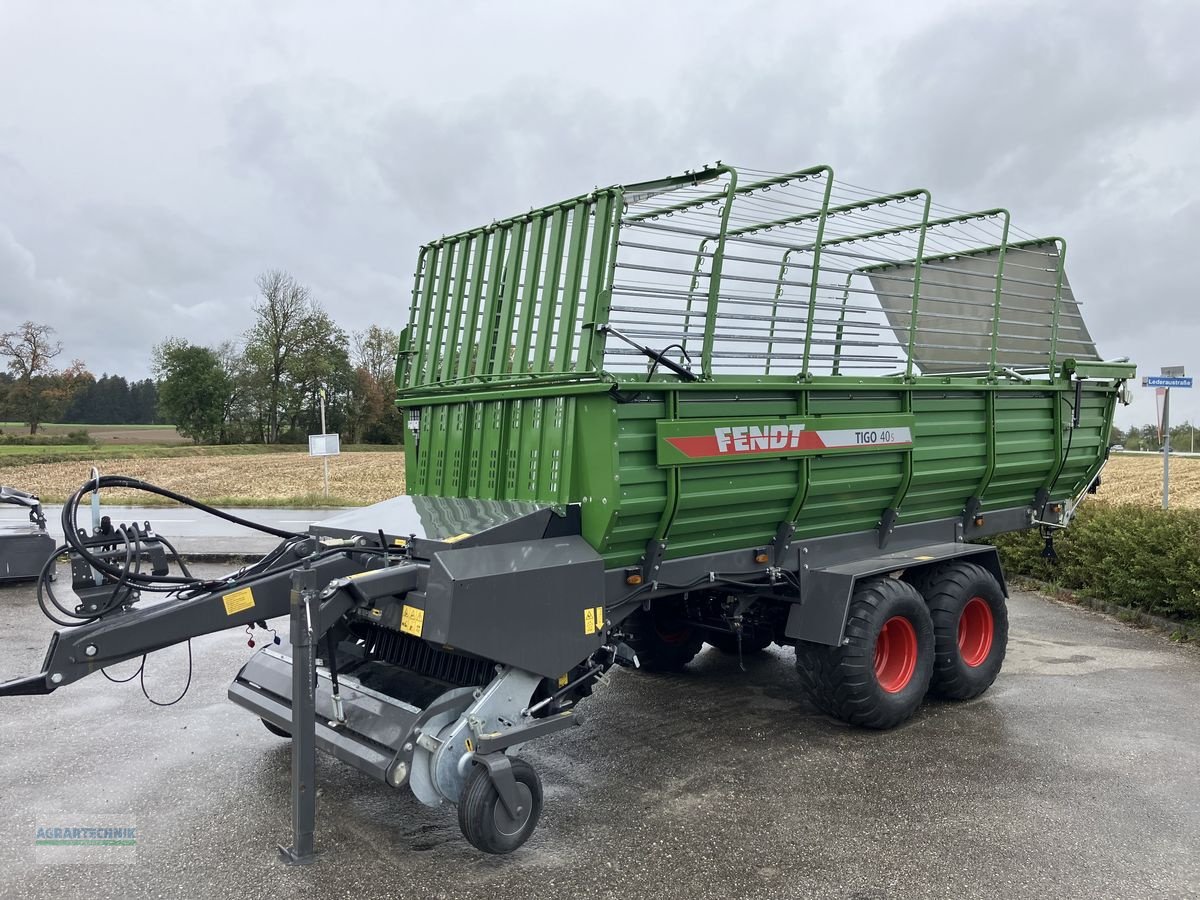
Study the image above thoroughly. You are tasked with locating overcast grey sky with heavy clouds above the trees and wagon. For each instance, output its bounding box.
[0,0,1200,425]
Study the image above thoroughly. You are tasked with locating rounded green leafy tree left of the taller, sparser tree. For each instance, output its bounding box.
[154,338,229,444]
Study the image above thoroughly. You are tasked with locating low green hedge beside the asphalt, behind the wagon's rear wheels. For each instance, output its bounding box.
[995,502,1200,619]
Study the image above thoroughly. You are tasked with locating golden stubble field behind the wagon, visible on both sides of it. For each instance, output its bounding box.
[0,446,1200,509]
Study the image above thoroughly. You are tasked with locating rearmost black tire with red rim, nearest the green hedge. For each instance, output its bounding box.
[912,560,1008,700]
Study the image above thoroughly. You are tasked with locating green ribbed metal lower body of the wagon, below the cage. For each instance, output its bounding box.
[406,379,1116,566]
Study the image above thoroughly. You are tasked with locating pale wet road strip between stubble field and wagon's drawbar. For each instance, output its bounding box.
[0,504,343,557]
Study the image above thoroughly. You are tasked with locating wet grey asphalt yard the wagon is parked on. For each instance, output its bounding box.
[0,566,1200,900]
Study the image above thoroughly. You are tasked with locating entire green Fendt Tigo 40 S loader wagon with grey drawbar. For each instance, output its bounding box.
[0,164,1134,860]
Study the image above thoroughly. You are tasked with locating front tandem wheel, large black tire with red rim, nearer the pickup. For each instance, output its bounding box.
[796,578,934,728]
